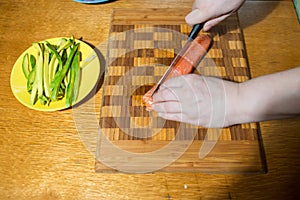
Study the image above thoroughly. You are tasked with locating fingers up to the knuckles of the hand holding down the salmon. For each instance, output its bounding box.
[151,74,202,126]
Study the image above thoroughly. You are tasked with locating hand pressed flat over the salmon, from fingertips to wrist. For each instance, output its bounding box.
[152,74,238,128]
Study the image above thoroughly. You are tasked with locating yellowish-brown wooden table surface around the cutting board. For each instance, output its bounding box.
[0,0,300,199]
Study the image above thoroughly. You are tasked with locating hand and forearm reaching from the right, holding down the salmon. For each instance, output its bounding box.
[151,67,300,128]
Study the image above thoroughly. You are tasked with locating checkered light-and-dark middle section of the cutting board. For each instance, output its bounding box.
[100,13,258,140]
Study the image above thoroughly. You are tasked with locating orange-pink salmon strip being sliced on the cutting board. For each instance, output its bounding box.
[143,34,212,111]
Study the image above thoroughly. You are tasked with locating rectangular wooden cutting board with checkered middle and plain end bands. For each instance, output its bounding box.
[96,8,266,173]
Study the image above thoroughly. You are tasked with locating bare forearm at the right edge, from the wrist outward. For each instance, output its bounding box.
[235,67,300,122]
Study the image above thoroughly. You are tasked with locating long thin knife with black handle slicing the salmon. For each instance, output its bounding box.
[150,23,204,97]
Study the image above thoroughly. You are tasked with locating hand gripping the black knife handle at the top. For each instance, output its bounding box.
[185,0,245,31]
